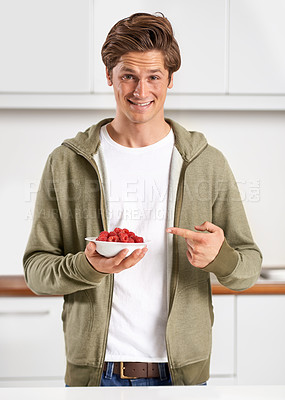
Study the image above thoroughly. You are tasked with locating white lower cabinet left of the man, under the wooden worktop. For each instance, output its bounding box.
[0,297,65,386]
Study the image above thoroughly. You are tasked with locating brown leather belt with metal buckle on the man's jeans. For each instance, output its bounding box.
[103,362,160,379]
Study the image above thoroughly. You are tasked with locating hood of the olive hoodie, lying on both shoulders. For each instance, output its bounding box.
[62,118,208,163]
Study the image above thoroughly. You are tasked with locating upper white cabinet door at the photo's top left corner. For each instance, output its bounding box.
[0,0,90,93]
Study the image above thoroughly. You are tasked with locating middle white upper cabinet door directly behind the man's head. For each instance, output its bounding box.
[94,0,226,94]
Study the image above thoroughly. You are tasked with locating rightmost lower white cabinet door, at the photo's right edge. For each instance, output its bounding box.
[237,295,285,385]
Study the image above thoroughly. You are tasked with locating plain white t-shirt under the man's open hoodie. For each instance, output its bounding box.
[100,126,174,362]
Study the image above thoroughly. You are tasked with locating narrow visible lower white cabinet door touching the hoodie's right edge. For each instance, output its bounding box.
[210,295,236,384]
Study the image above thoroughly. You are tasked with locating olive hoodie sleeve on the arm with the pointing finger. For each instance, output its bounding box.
[204,156,262,290]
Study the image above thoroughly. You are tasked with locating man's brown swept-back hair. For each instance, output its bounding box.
[101,13,181,78]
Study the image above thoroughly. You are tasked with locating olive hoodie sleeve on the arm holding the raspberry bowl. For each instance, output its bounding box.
[23,156,106,295]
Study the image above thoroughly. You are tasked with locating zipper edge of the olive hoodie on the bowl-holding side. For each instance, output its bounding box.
[63,142,114,386]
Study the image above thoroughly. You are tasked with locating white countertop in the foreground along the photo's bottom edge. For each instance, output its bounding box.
[0,385,285,400]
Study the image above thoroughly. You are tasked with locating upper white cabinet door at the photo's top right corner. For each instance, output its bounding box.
[229,0,285,94]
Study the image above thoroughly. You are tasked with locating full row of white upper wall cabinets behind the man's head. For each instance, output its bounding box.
[0,0,285,111]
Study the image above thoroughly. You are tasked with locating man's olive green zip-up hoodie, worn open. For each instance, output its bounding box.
[24,119,262,386]
